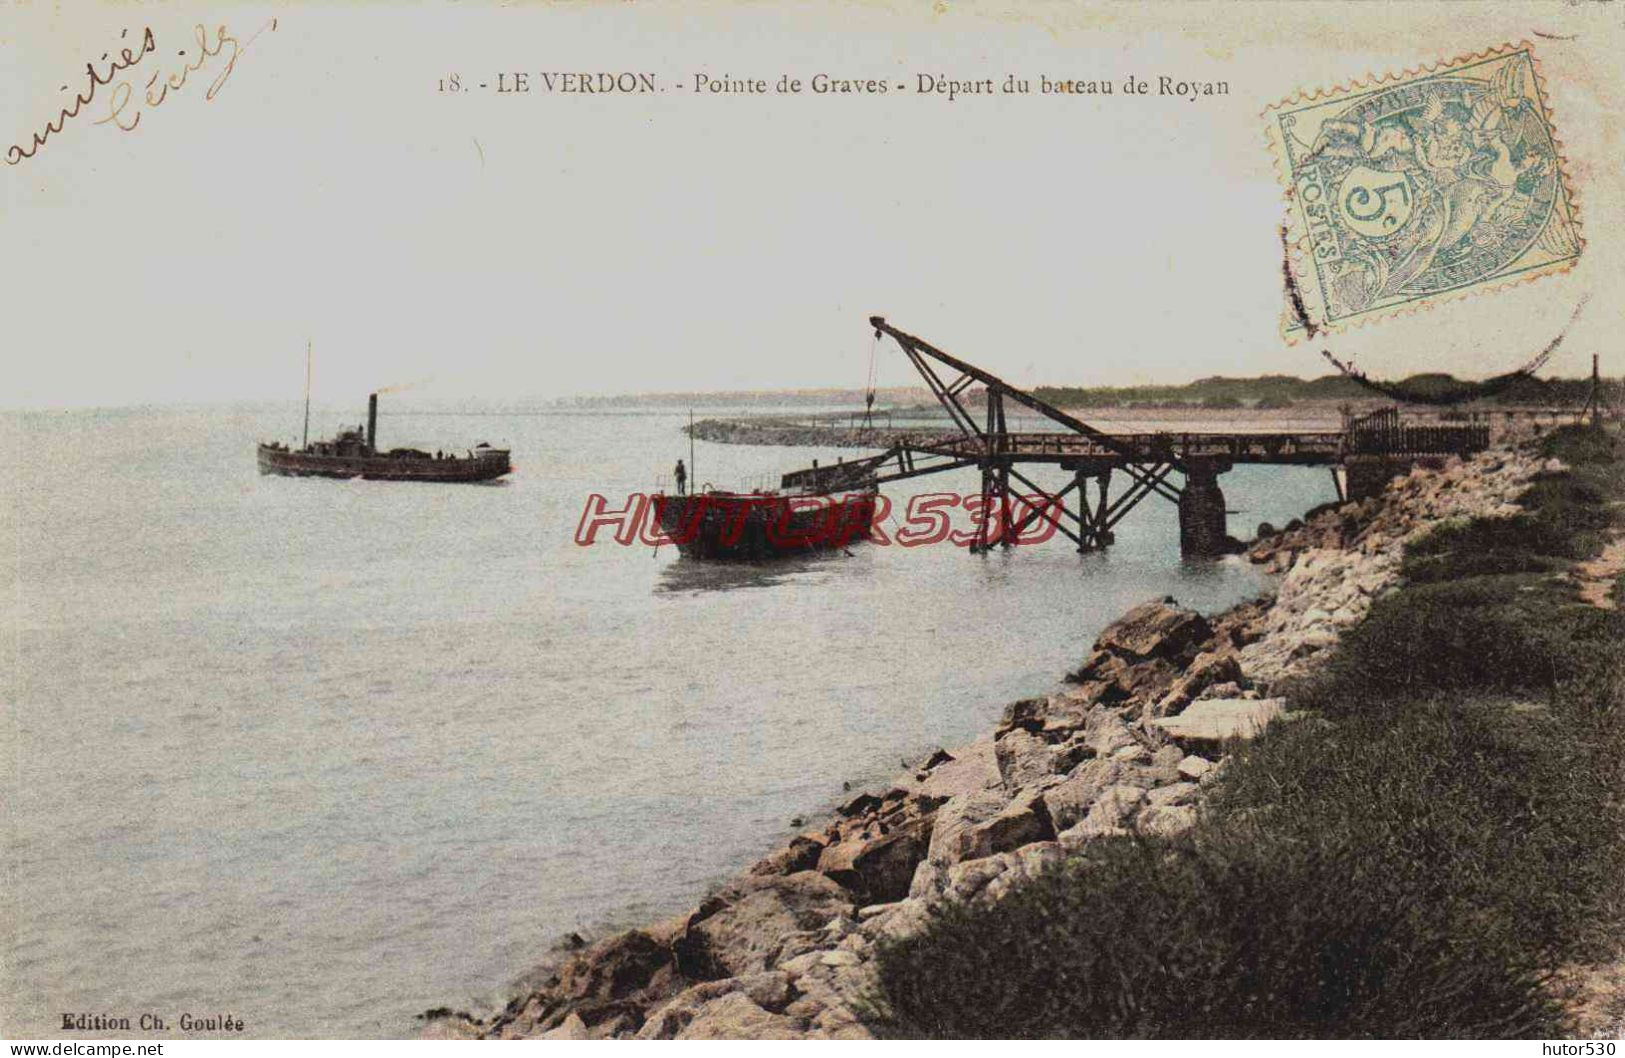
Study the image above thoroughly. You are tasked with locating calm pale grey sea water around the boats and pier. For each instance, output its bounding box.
[0,400,1333,1037]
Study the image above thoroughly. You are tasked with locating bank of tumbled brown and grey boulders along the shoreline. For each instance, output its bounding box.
[426,452,1560,1038]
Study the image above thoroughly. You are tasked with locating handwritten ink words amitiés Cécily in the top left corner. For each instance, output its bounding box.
[5,18,276,166]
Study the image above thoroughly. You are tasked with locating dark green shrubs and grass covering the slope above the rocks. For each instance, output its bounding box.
[866,431,1625,1037]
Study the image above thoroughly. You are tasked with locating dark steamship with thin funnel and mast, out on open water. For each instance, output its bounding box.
[258,393,514,481]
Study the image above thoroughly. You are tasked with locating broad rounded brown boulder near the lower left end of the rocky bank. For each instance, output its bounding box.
[678,871,856,980]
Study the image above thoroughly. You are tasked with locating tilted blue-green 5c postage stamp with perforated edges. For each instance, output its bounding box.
[1264,44,1584,338]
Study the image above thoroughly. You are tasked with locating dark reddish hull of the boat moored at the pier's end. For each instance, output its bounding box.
[655,489,876,561]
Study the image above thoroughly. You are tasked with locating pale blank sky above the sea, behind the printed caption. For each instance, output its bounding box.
[0,0,1625,408]
